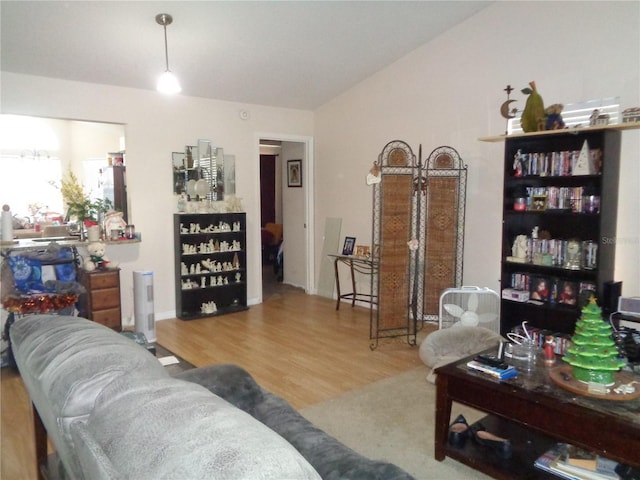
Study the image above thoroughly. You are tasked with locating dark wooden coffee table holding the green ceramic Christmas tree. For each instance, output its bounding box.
[435,349,640,479]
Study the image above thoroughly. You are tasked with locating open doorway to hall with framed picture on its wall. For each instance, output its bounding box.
[258,134,314,301]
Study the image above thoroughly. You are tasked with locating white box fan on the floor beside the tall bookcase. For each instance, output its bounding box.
[438,286,500,333]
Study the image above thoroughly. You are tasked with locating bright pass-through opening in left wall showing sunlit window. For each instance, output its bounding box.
[0,114,131,229]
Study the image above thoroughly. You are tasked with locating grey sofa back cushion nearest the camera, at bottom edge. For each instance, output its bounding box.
[73,372,320,480]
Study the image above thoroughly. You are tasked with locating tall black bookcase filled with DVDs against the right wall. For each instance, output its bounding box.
[500,128,621,335]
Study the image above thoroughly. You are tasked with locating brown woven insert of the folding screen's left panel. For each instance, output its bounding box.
[378,175,412,330]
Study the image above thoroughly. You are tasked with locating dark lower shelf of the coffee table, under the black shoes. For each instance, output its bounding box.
[445,415,559,480]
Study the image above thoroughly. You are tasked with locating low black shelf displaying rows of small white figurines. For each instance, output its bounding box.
[174,213,247,320]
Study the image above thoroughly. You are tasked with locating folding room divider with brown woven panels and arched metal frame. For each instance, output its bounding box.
[370,140,467,349]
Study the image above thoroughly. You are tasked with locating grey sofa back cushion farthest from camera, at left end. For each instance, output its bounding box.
[10,315,168,478]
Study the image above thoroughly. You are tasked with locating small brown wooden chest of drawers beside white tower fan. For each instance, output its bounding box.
[78,269,122,331]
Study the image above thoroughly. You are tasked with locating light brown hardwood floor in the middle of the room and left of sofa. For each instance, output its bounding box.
[0,286,432,480]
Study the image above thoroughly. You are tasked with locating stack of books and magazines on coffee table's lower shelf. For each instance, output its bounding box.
[534,443,620,480]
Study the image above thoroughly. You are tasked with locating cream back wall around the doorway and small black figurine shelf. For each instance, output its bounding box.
[1,72,313,320]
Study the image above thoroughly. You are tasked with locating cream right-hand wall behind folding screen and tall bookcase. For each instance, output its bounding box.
[315,1,640,295]
